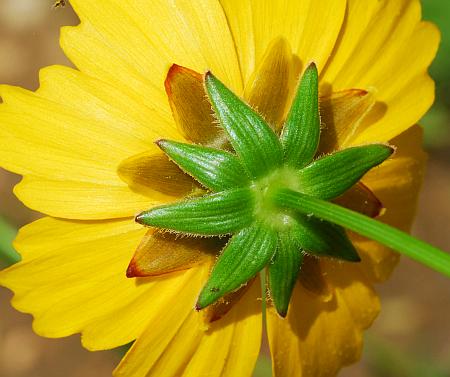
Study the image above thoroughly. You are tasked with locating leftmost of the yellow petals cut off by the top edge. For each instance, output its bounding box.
[61,0,242,100]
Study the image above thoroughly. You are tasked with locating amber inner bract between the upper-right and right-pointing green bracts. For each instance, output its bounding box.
[319,89,375,153]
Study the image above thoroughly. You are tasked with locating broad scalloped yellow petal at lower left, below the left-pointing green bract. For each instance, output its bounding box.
[0,218,201,350]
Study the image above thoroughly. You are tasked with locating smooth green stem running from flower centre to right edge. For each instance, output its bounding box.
[271,189,450,277]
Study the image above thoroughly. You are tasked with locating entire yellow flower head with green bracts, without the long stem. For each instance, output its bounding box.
[0,0,439,377]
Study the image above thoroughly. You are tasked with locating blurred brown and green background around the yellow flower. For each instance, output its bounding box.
[0,0,450,377]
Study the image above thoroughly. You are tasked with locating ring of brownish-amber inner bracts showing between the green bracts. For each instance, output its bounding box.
[118,39,382,321]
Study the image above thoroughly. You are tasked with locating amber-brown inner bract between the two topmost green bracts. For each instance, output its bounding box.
[244,38,294,129]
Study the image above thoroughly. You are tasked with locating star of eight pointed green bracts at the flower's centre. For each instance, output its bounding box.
[136,64,393,316]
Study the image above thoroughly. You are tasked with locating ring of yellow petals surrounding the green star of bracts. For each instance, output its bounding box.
[0,0,439,377]
